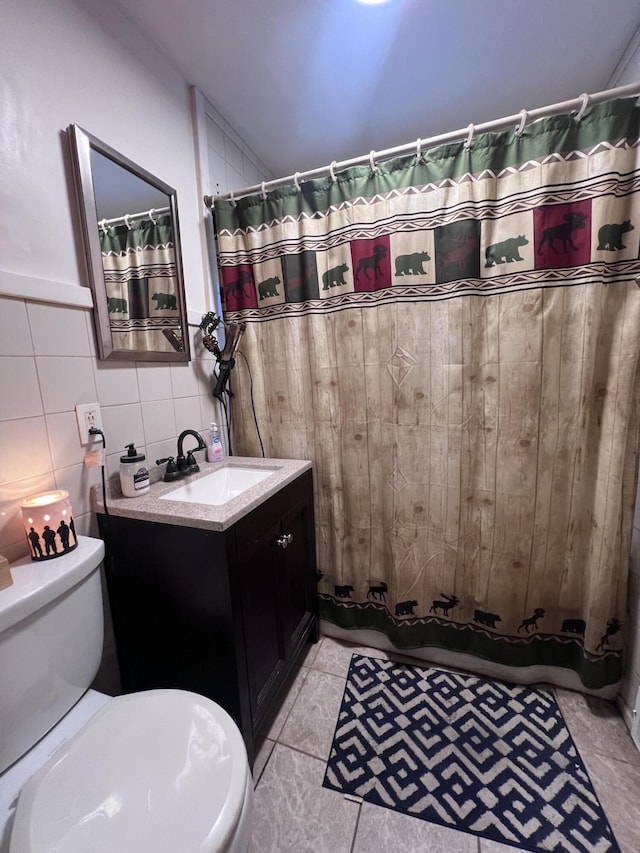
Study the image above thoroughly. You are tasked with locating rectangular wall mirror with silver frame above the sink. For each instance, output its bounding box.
[67,124,190,361]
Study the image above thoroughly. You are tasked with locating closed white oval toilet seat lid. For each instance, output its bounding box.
[10,690,249,853]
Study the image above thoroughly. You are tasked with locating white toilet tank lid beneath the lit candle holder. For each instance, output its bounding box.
[0,536,104,632]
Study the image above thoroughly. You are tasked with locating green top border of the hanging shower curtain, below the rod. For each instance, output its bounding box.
[214,98,640,231]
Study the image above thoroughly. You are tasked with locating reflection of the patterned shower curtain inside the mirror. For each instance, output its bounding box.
[100,215,183,352]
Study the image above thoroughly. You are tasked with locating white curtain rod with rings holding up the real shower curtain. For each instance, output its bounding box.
[204,82,640,208]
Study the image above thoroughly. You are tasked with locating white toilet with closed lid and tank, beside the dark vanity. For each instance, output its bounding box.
[0,536,253,853]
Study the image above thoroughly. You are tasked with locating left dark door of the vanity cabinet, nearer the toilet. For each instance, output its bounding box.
[238,521,284,726]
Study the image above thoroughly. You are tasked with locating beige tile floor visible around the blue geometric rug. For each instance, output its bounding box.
[250,637,640,853]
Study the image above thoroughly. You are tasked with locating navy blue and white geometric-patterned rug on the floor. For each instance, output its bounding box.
[323,655,620,853]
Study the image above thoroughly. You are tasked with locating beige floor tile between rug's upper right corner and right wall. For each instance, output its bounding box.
[555,687,640,764]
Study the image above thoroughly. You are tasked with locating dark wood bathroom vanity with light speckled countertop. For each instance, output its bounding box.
[92,457,317,763]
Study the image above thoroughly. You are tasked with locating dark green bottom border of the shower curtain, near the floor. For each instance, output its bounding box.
[318,595,622,690]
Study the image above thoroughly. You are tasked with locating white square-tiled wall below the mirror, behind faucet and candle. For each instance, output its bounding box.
[0,297,215,560]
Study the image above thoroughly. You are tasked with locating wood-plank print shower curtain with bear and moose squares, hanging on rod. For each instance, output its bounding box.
[214,99,640,692]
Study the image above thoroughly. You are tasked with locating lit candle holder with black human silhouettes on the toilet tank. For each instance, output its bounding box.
[20,489,78,560]
